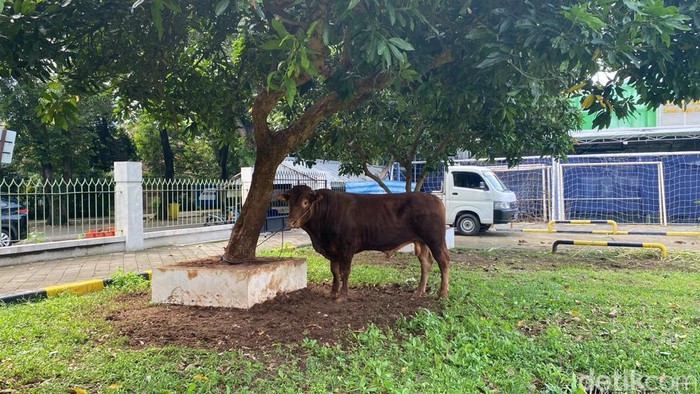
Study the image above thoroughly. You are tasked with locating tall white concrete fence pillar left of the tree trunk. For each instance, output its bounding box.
[114,161,143,252]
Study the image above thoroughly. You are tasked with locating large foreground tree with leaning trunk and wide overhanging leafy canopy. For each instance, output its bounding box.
[0,0,700,259]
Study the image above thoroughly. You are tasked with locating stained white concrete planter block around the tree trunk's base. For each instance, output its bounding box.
[151,258,307,309]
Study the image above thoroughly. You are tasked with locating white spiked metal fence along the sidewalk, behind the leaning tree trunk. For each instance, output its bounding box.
[0,167,337,249]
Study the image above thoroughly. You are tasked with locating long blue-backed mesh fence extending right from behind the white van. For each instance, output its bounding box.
[402,152,700,225]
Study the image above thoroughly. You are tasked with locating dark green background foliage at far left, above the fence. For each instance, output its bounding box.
[0,78,136,180]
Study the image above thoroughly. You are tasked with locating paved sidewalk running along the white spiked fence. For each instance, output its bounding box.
[0,230,311,298]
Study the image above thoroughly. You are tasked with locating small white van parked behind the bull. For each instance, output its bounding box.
[436,166,518,235]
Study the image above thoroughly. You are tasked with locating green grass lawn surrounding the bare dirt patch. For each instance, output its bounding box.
[0,249,700,393]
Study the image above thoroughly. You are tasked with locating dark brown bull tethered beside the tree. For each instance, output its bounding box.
[280,185,450,301]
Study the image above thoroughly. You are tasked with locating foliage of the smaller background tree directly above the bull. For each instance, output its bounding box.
[296,84,581,191]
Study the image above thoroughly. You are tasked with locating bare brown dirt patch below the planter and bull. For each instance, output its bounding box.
[106,283,439,350]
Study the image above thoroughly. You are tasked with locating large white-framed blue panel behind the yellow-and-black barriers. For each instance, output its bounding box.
[555,161,666,225]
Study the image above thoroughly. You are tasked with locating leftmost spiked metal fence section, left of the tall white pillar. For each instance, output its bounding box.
[0,179,114,246]
